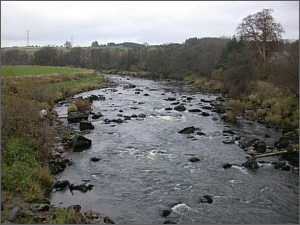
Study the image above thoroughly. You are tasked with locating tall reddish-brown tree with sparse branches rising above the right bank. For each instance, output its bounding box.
[237,9,284,64]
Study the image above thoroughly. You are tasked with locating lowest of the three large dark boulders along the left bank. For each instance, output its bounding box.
[63,132,92,151]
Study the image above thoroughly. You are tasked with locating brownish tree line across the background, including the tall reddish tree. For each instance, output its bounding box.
[1,9,299,95]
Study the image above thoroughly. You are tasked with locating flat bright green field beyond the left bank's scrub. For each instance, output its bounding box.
[1,66,91,77]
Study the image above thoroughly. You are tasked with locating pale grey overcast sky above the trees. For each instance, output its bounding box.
[1,1,299,47]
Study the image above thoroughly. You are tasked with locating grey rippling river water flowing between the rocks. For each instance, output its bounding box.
[51,75,299,224]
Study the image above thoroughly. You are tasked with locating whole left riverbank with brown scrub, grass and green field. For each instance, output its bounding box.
[1,66,108,223]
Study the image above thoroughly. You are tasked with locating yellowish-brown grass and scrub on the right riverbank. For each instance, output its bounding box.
[186,77,299,134]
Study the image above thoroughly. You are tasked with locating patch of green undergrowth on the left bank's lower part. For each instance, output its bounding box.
[1,138,51,199]
